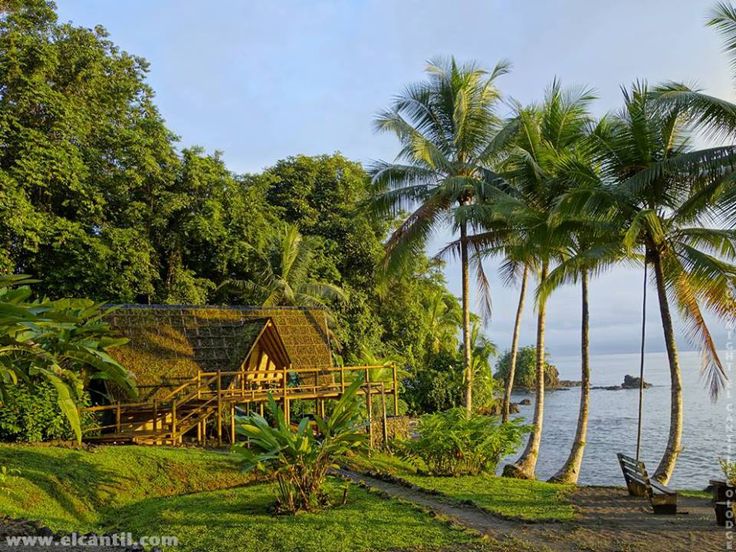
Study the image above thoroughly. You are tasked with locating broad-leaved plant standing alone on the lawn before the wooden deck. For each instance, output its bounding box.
[235,380,367,514]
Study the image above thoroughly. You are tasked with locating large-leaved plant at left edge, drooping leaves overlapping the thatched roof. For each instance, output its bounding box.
[0,275,135,440]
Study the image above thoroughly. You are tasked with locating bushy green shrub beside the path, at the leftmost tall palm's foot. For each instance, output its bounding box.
[400,408,531,475]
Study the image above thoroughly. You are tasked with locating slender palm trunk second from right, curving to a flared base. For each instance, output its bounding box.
[550,270,590,483]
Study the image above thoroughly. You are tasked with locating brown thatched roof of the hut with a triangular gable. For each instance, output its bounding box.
[108,305,332,399]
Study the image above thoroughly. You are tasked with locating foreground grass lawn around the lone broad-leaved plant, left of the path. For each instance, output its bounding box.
[109,478,479,552]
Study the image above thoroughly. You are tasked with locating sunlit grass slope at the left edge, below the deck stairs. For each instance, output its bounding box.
[0,445,252,532]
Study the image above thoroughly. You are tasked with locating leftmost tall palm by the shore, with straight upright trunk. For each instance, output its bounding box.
[372,59,509,410]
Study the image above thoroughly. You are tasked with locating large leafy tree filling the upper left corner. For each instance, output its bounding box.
[0,0,177,301]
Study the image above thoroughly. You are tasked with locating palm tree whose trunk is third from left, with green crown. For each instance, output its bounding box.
[483,81,593,478]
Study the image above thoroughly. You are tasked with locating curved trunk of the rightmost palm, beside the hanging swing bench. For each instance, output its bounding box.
[651,251,682,484]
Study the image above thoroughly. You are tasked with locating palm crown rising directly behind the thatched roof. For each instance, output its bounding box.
[221,224,345,307]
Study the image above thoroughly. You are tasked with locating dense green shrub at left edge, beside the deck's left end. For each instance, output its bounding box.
[0,381,95,443]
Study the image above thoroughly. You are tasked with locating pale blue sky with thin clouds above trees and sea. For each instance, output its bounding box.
[58,0,734,358]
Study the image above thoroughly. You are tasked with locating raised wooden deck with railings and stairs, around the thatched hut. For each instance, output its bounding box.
[85,365,399,445]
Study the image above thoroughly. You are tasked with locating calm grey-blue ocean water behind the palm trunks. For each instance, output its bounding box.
[504,351,736,489]
